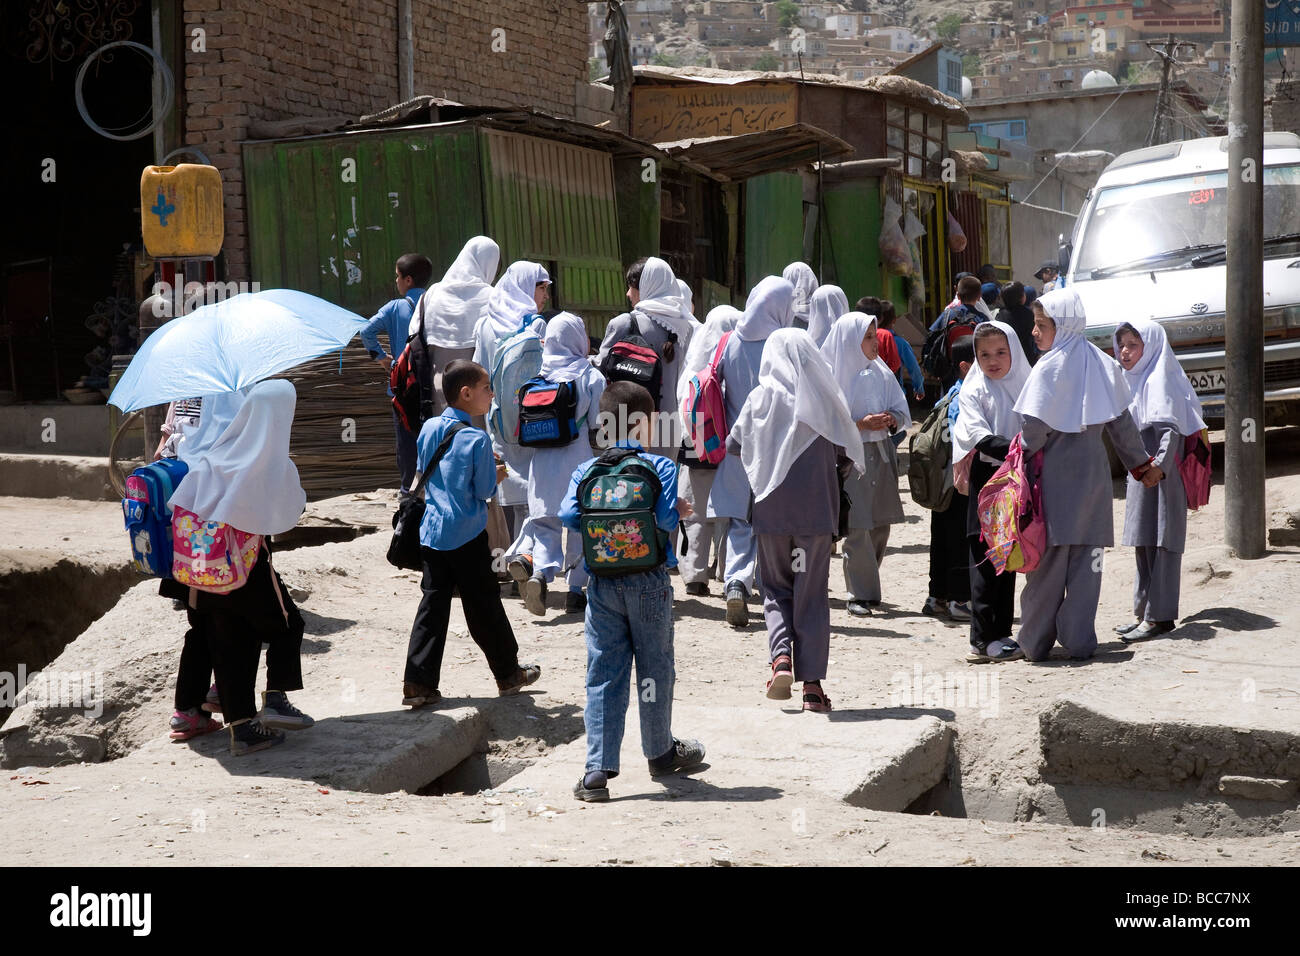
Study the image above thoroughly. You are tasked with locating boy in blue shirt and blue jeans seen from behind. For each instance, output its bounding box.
[560,381,705,803]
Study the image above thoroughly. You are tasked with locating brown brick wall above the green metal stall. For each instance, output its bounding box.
[183,0,588,281]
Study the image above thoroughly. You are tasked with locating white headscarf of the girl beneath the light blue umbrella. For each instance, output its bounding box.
[168,378,307,535]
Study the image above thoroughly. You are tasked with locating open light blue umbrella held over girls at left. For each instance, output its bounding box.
[108,289,367,412]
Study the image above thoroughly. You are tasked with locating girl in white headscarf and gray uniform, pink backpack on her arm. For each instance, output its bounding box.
[1015,287,1151,661]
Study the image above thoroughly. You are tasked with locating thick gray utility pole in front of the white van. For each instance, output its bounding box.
[1223,0,1266,558]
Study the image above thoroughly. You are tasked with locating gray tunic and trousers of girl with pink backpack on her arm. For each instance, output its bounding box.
[1017,408,1148,661]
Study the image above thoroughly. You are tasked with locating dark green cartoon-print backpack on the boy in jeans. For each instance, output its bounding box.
[577,447,668,578]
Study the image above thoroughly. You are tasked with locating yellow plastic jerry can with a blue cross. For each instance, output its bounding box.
[140,163,225,259]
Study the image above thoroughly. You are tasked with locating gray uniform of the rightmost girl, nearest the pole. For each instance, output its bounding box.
[1121,421,1187,620]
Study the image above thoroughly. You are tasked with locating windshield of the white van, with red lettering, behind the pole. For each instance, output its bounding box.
[1073,165,1300,281]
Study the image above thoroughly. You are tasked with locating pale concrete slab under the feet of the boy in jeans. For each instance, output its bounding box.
[508,704,952,810]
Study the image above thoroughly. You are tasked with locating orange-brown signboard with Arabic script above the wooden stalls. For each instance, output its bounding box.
[632,83,798,143]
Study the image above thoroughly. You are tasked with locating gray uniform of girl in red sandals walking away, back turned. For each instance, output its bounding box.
[754,437,840,680]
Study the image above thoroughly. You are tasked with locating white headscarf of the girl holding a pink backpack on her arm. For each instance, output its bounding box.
[1015,289,1131,433]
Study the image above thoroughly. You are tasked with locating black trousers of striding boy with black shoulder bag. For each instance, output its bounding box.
[403,531,519,688]
